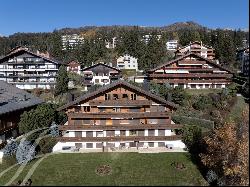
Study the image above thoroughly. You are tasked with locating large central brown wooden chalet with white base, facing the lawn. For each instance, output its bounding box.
[53,81,185,151]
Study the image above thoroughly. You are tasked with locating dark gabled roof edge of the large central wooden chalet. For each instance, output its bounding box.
[57,80,178,111]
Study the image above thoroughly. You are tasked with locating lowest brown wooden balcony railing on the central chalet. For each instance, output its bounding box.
[57,135,182,142]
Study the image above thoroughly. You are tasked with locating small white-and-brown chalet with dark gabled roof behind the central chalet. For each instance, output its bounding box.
[82,63,121,87]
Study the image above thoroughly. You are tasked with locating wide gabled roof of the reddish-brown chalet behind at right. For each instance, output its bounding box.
[148,53,233,73]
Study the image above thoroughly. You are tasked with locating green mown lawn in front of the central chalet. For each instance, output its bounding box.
[0,153,207,186]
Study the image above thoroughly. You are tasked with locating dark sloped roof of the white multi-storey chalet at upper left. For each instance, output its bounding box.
[0,47,67,65]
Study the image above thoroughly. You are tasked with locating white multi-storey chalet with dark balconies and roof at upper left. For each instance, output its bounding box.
[0,48,62,89]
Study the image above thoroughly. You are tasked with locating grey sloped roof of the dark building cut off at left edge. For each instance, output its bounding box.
[0,81,44,116]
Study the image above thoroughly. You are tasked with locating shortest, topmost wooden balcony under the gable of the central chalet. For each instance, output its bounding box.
[89,100,152,106]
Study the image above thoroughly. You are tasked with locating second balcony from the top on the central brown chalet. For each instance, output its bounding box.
[67,112,171,119]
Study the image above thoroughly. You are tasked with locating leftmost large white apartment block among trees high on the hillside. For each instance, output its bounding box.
[61,34,84,50]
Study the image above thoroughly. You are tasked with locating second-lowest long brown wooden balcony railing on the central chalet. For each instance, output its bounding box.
[59,124,183,130]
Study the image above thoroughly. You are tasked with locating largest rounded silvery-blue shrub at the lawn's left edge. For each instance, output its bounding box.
[16,140,36,164]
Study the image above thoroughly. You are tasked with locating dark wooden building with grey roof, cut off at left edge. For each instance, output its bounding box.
[0,81,43,145]
